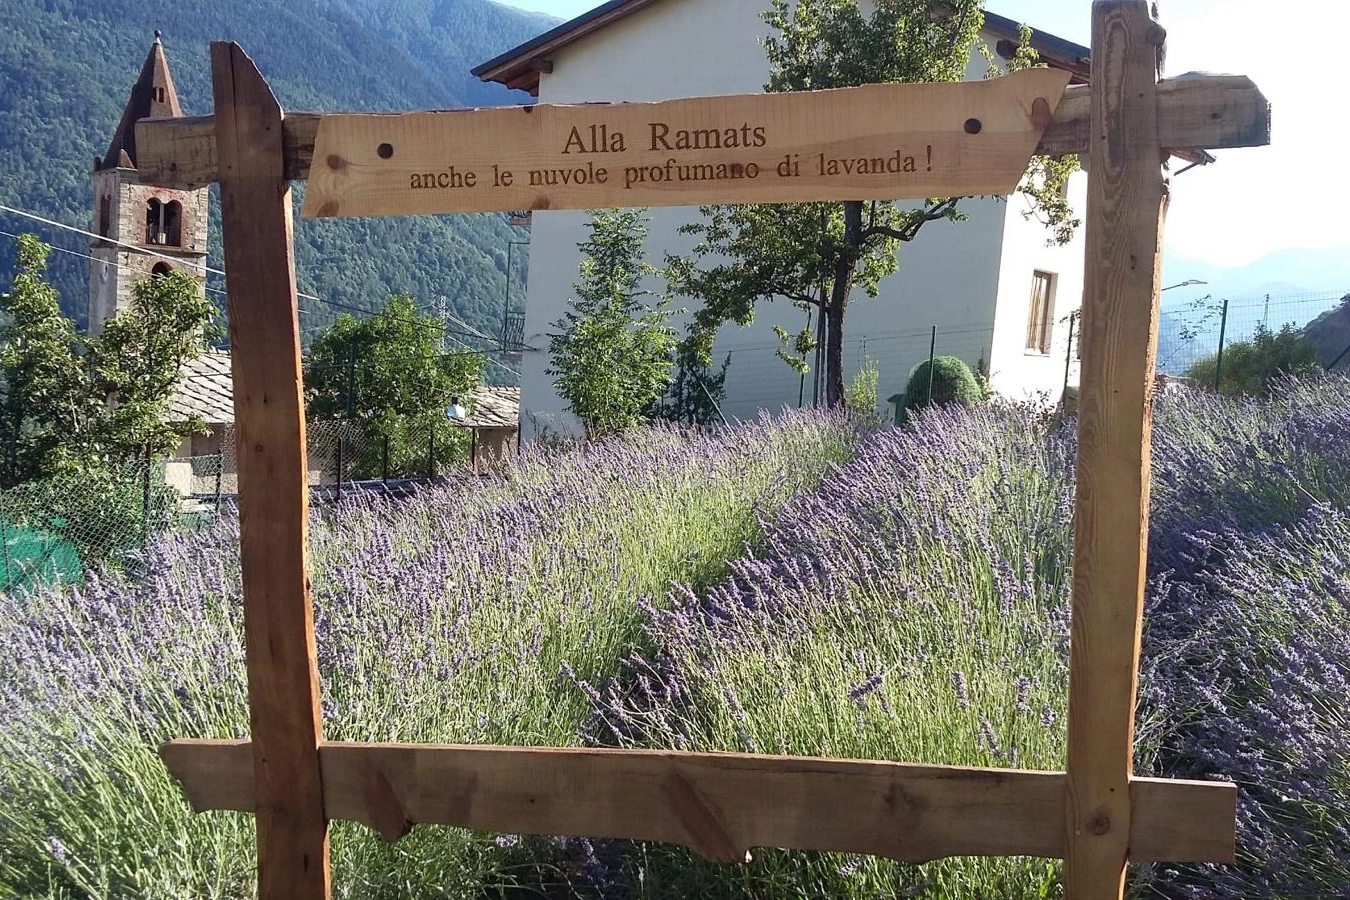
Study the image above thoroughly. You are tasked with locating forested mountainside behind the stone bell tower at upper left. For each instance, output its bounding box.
[0,0,555,333]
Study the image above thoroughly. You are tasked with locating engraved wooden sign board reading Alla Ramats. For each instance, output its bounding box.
[302,69,1069,217]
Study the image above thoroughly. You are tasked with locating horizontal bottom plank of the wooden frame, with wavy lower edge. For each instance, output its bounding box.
[161,741,1237,862]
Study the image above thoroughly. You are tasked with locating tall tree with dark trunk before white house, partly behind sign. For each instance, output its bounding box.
[667,0,1077,406]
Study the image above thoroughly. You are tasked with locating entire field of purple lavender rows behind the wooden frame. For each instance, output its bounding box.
[0,379,1350,900]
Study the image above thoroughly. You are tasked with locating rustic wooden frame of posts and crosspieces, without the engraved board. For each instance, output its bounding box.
[138,0,1269,900]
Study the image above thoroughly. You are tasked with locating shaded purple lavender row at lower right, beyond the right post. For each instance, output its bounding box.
[1141,506,1350,900]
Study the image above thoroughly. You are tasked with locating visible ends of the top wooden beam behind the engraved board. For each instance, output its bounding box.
[136,76,1270,188]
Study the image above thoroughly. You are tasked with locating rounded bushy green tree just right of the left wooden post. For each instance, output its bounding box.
[305,296,486,478]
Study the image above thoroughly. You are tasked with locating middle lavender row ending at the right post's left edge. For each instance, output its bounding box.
[593,406,1073,899]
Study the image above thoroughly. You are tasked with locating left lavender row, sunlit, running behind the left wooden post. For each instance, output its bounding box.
[0,414,853,899]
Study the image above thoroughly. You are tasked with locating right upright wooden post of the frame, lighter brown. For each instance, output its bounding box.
[1064,0,1168,900]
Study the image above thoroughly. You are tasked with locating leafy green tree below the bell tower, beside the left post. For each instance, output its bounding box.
[88,271,221,464]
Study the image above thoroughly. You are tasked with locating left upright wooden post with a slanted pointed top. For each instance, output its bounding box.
[211,43,329,900]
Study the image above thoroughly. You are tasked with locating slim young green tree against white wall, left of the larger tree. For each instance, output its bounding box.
[548,209,676,440]
